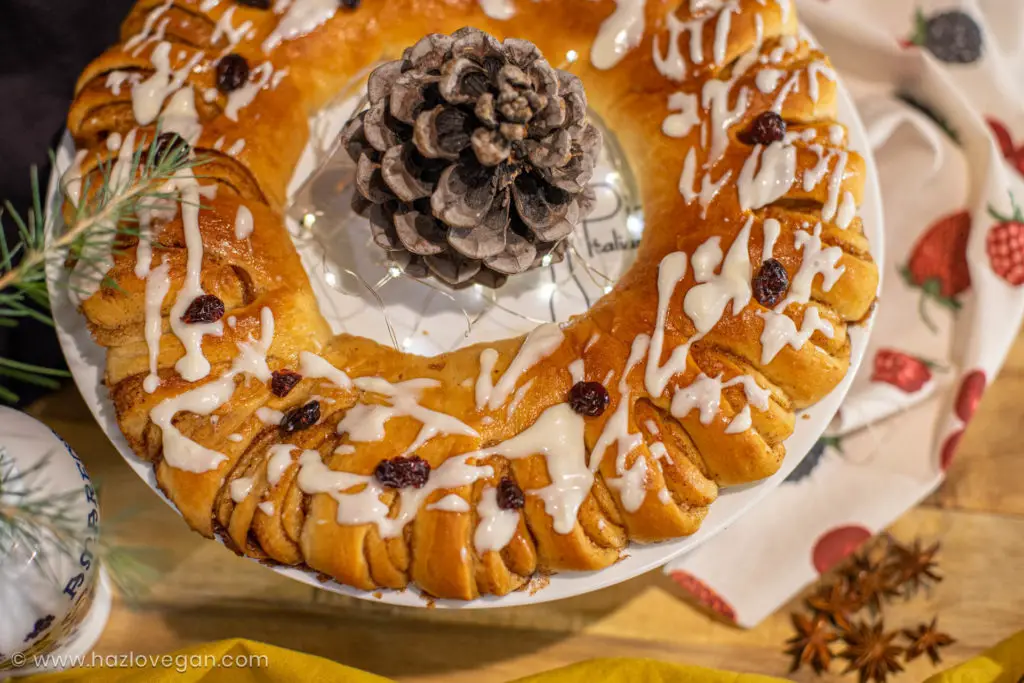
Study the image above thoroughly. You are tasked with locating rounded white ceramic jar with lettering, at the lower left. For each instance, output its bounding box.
[0,408,111,679]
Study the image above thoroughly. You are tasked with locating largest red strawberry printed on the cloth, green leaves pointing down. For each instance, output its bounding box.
[900,211,971,330]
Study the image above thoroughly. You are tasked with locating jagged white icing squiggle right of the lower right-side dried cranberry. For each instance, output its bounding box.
[758,223,846,365]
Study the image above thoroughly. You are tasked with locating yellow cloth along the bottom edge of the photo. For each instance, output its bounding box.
[26,631,1024,683]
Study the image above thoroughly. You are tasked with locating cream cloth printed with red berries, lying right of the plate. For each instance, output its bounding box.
[666,0,1024,627]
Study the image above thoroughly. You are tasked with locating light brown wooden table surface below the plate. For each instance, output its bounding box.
[31,336,1024,683]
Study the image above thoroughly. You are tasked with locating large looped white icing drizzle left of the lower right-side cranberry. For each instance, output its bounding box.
[644,216,754,397]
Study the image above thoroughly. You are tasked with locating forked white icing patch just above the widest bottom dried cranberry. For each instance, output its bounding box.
[338,377,479,454]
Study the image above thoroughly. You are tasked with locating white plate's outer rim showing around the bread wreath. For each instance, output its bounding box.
[45,27,885,609]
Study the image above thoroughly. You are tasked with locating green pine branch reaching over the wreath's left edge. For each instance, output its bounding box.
[0,128,203,402]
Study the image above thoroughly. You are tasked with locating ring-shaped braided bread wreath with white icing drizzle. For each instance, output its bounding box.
[49,0,879,600]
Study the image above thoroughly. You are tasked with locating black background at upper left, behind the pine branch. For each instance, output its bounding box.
[0,0,134,403]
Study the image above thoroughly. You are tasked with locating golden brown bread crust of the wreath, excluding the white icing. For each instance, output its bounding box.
[69,0,878,599]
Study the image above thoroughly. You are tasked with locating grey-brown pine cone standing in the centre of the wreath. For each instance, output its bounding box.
[341,28,601,287]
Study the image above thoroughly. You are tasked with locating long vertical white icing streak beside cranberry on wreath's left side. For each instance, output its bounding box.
[170,169,224,382]
